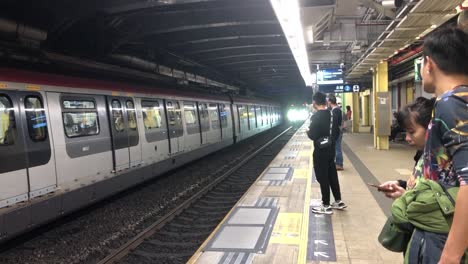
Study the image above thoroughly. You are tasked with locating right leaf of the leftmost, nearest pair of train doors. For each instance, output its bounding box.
[18,92,57,198]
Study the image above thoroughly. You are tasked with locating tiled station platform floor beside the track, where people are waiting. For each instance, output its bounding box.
[188,122,415,264]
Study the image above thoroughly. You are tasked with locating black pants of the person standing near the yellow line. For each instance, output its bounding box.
[314,150,341,205]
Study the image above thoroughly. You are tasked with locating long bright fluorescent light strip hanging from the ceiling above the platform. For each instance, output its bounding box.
[270,0,313,86]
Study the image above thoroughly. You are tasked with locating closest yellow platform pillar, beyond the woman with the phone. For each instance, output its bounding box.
[372,61,391,150]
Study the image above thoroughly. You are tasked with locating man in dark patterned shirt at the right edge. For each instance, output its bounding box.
[416,28,468,264]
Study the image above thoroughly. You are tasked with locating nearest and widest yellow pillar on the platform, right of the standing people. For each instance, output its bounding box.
[373,61,391,150]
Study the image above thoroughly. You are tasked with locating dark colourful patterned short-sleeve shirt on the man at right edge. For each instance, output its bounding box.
[415,86,468,187]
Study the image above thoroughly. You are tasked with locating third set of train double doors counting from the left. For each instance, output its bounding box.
[166,100,184,154]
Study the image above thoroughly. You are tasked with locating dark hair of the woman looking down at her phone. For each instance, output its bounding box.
[397,97,435,130]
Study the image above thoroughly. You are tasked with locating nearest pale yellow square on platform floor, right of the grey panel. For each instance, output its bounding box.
[270,213,302,245]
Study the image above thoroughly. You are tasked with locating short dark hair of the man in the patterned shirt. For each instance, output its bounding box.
[423,27,468,75]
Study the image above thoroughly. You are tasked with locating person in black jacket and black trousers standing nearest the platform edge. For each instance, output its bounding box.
[308,92,346,214]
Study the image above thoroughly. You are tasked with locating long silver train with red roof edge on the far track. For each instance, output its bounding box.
[0,68,283,242]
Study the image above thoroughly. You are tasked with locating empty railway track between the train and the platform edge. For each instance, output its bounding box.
[98,127,294,264]
